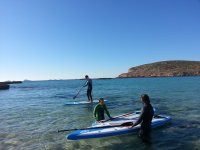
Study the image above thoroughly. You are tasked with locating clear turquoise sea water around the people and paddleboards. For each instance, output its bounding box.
[0,77,200,150]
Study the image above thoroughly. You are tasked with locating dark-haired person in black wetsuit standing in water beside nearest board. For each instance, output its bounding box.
[131,94,154,144]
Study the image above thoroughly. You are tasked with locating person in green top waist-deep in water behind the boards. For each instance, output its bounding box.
[93,98,112,122]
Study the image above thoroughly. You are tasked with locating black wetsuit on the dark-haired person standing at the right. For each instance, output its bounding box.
[134,104,154,142]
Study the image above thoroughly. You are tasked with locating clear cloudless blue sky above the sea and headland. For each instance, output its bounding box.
[0,0,200,81]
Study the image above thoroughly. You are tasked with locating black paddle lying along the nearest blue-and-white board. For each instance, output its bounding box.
[58,122,133,132]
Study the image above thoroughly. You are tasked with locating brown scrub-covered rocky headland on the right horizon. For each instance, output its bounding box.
[118,60,200,78]
